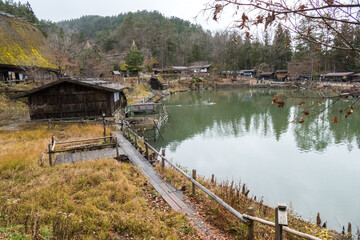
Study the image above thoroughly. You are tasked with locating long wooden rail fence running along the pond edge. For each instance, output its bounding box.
[122,125,320,240]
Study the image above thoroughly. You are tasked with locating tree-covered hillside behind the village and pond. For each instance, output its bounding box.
[0,0,360,76]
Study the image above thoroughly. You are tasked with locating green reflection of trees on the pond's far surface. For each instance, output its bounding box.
[156,90,360,151]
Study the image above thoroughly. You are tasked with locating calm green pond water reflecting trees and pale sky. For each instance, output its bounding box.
[153,89,360,233]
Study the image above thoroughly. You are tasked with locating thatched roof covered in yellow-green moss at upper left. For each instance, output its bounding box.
[0,14,56,68]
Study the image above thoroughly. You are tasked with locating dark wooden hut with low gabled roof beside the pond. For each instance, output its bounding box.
[16,78,128,120]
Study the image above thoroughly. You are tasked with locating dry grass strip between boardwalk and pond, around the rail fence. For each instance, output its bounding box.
[156,165,346,239]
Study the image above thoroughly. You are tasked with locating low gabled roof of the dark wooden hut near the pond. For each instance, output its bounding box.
[13,78,129,98]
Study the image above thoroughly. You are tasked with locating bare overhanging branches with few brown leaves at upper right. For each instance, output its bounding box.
[204,0,360,53]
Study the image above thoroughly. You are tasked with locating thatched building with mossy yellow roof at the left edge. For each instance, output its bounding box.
[0,12,57,83]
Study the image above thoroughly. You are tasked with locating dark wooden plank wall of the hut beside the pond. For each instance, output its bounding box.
[29,82,126,119]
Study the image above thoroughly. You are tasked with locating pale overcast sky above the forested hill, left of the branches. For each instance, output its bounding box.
[20,0,233,31]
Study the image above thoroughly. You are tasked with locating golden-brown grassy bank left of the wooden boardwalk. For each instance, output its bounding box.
[0,124,196,239]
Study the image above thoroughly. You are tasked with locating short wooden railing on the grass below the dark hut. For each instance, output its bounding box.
[48,135,119,166]
